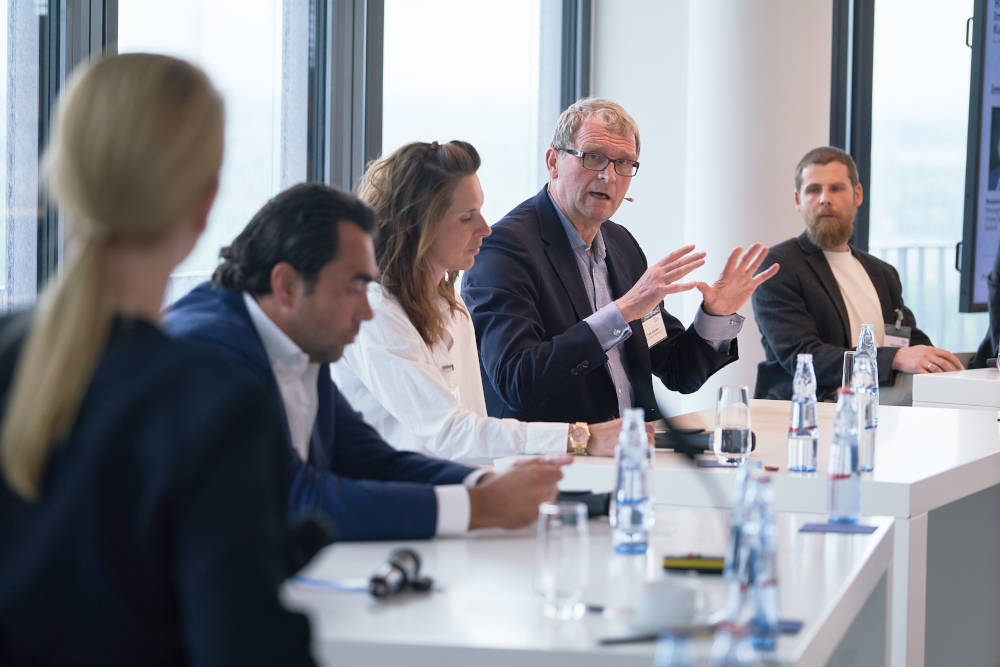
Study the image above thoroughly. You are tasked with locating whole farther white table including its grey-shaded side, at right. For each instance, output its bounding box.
[496,400,1000,666]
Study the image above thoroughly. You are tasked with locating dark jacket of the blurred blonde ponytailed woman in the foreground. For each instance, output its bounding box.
[0,317,312,665]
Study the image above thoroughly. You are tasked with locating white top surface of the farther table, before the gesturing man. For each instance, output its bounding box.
[504,400,1000,517]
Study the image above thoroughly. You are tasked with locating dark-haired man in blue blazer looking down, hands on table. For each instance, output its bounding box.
[165,184,568,540]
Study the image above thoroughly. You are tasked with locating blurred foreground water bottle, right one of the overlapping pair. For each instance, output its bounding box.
[744,472,778,651]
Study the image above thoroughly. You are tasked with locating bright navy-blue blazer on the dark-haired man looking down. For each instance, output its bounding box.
[165,283,473,540]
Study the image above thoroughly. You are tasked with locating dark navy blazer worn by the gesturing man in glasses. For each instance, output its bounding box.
[462,187,737,422]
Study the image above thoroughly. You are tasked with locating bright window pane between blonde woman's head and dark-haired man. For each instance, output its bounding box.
[118,0,310,303]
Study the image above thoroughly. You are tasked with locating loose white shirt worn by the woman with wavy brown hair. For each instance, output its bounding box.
[330,283,568,463]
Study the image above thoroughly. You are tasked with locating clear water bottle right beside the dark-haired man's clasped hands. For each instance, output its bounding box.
[610,408,654,553]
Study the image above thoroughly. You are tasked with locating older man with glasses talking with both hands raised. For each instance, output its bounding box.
[462,98,778,438]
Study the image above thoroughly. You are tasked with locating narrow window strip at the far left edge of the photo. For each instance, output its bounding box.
[0,0,39,312]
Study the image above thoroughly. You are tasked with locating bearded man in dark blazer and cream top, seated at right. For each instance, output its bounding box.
[753,146,962,399]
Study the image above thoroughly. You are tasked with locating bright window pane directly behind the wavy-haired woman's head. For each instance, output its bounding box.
[382,0,562,223]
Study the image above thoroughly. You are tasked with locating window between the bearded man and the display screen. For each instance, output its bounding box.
[866,0,988,352]
